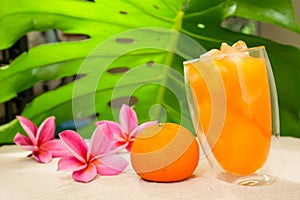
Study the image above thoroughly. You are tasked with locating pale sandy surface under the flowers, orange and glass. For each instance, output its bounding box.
[0,137,300,200]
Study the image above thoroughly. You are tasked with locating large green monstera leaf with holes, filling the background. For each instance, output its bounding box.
[0,0,300,143]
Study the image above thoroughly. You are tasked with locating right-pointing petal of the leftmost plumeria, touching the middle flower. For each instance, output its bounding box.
[40,139,69,158]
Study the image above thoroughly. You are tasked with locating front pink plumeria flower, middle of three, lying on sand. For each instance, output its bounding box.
[58,126,128,183]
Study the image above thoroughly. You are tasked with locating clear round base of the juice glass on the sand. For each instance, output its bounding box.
[217,173,274,186]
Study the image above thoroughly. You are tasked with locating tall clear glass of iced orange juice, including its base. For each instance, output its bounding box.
[184,41,279,185]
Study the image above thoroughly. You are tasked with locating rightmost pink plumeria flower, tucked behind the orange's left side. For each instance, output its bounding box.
[96,104,157,151]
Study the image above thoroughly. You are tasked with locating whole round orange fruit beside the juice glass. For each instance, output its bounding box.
[130,123,199,182]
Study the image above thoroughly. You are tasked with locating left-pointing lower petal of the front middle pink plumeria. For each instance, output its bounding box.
[57,156,87,171]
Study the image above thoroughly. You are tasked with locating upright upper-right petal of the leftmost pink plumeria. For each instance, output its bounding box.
[36,116,55,145]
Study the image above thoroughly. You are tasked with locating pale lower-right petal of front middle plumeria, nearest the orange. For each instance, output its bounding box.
[96,154,128,175]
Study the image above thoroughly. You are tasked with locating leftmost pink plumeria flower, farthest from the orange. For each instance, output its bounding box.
[14,116,67,163]
